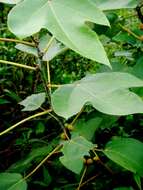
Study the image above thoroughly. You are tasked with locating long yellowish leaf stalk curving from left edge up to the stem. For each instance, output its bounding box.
[0,109,52,136]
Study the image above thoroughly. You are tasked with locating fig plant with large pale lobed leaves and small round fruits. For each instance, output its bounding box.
[0,0,143,190]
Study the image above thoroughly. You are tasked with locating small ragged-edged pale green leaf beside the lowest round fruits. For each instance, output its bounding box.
[60,136,94,174]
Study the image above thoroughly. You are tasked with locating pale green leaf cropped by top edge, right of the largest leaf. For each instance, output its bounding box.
[92,0,137,10]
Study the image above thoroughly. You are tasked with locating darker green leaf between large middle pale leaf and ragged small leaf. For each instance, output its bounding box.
[72,117,102,141]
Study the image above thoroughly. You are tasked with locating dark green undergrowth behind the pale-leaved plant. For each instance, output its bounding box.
[0,0,143,190]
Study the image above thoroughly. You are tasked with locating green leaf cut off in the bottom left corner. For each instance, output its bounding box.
[0,173,27,190]
